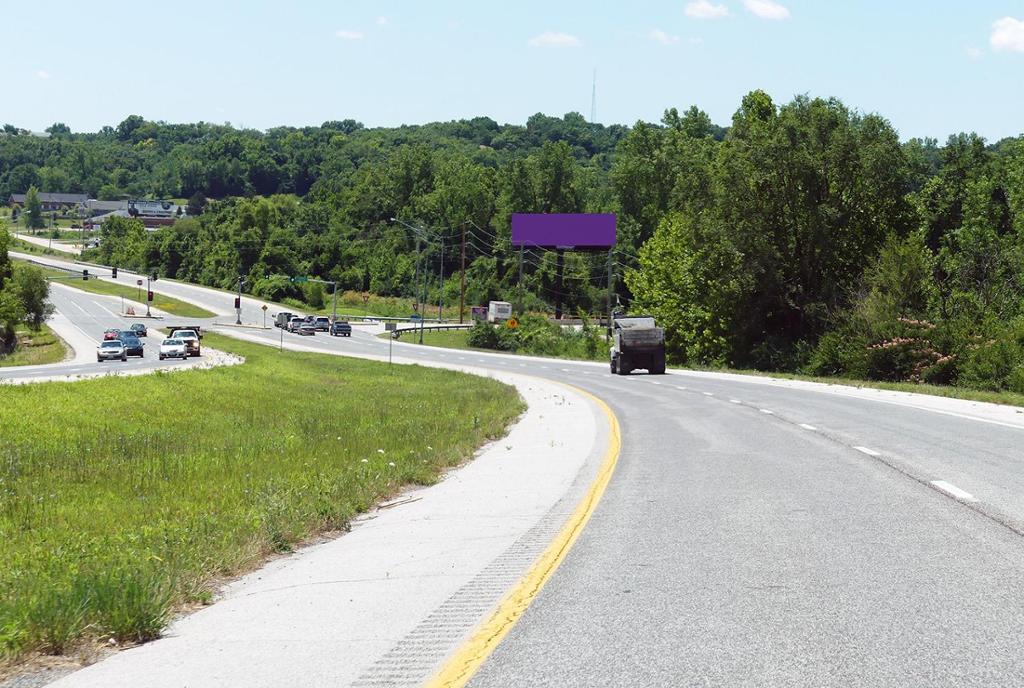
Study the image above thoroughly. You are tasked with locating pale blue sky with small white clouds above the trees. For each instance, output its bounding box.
[8,0,1024,140]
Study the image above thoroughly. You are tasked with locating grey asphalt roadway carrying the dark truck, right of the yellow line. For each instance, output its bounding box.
[8,262,1024,687]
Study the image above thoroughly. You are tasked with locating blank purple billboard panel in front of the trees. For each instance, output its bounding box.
[512,213,615,251]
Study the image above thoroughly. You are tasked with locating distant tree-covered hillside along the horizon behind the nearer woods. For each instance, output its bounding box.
[0,113,628,200]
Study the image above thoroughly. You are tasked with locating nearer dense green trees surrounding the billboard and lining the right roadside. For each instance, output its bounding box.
[22,91,1024,389]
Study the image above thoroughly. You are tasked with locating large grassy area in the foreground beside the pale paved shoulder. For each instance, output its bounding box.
[0,334,523,665]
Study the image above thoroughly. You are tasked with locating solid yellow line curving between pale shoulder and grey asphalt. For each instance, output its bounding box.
[424,385,622,688]
